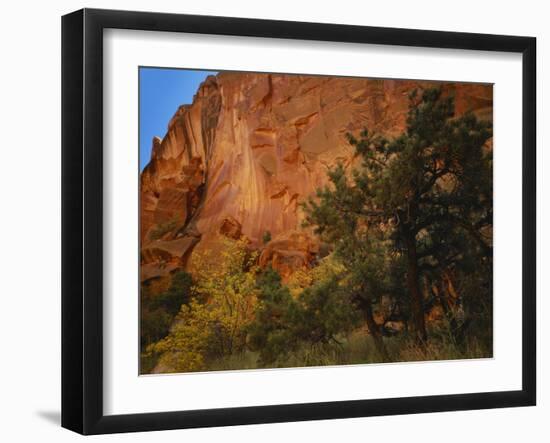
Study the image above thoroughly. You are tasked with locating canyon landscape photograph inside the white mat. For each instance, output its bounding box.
[136,66,496,375]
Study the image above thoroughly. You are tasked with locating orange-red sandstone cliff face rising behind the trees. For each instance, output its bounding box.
[140,73,492,280]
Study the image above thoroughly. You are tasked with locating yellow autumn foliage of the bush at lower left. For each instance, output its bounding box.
[149,238,258,372]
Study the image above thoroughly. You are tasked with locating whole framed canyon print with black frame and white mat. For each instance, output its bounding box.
[62,9,536,434]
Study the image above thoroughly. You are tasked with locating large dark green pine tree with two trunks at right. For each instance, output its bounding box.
[305,88,493,346]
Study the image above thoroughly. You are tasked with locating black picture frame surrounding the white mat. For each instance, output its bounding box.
[62,9,536,434]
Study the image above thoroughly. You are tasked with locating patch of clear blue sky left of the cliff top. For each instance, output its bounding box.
[139,68,216,171]
